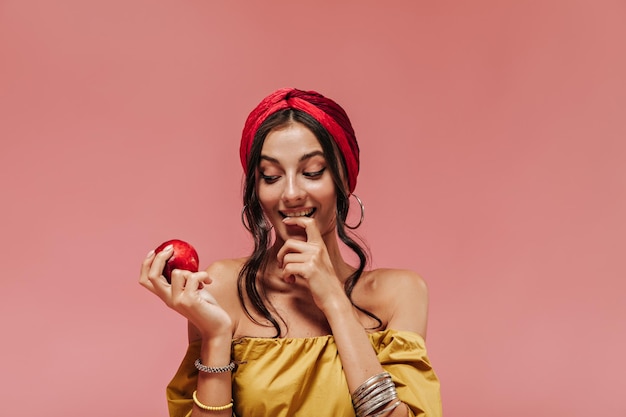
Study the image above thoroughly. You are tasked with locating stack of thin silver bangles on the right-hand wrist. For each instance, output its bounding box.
[352,372,402,417]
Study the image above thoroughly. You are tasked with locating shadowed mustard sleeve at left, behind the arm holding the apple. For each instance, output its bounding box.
[166,340,202,417]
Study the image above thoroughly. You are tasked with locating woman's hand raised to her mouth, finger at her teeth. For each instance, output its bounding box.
[277,217,345,311]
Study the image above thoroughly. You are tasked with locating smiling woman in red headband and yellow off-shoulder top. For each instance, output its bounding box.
[140,88,441,417]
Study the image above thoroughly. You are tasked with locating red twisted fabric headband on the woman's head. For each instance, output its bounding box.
[239,88,359,192]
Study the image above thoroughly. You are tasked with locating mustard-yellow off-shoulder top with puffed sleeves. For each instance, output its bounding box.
[167,329,441,417]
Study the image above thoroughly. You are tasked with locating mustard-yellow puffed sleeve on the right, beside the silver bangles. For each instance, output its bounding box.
[370,330,442,417]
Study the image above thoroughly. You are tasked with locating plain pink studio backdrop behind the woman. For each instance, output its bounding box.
[0,0,626,417]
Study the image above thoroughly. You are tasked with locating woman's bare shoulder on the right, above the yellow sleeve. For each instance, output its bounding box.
[362,268,428,338]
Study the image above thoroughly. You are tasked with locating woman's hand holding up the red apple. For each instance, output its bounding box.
[139,248,233,339]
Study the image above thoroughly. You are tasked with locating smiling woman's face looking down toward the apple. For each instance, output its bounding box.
[256,122,336,241]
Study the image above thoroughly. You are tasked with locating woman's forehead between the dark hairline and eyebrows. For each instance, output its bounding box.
[261,123,323,159]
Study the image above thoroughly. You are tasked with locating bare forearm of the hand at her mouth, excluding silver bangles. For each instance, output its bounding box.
[326,298,408,417]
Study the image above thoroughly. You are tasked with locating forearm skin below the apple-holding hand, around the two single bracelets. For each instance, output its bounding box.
[191,335,232,417]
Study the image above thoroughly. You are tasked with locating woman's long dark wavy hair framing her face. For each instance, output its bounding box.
[237,108,382,337]
